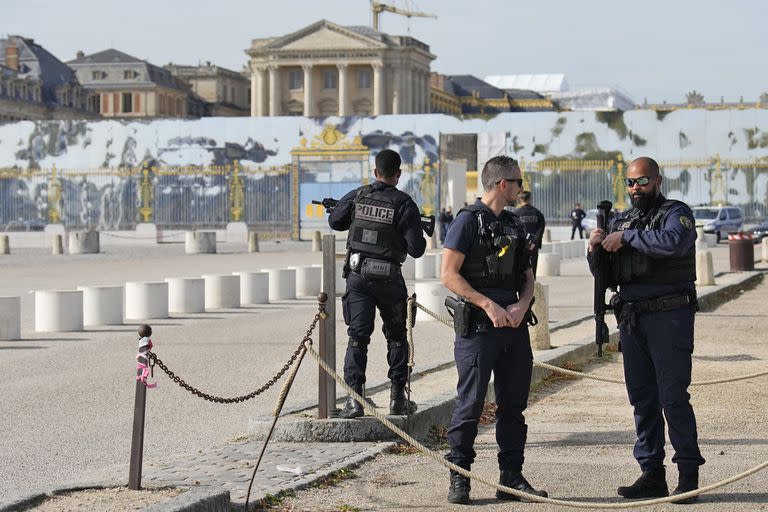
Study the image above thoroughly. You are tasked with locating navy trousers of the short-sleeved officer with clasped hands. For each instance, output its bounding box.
[446,325,533,471]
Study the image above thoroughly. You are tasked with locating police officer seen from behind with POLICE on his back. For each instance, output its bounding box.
[328,149,427,418]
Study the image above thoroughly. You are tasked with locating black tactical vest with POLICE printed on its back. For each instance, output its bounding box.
[347,185,408,264]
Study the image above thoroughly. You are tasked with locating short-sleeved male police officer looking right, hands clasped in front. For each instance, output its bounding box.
[442,156,547,503]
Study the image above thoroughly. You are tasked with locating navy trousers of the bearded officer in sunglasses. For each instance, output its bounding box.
[619,307,704,470]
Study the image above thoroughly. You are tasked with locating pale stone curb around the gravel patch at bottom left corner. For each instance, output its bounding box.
[0,482,230,512]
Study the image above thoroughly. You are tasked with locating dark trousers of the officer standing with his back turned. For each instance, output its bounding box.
[341,272,408,387]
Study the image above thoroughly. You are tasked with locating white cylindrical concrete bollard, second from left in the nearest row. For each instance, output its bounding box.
[35,290,83,332]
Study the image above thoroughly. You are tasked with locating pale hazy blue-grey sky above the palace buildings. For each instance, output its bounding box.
[6,0,768,103]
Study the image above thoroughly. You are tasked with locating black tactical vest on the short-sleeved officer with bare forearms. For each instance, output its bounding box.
[457,204,528,291]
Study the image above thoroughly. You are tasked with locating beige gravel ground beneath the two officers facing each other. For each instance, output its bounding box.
[274,284,768,512]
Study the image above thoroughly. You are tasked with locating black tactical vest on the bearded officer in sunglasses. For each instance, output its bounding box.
[611,195,696,284]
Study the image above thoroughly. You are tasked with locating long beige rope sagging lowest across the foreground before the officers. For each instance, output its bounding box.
[307,346,768,509]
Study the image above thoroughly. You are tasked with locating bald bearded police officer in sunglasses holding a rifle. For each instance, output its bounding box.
[587,157,704,503]
